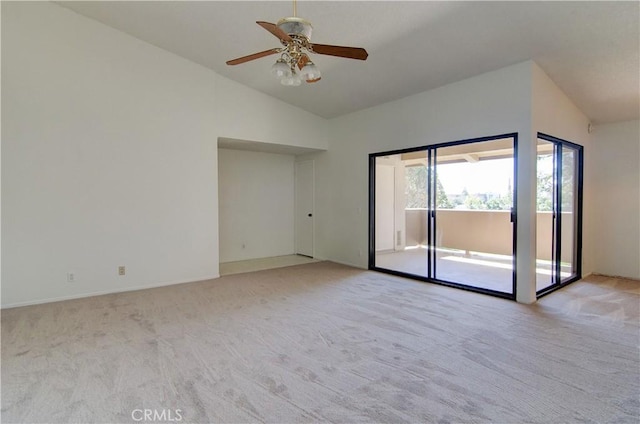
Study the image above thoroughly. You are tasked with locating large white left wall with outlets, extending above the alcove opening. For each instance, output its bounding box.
[2,2,326,307]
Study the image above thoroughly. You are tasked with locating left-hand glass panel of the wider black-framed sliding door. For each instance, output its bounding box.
[375,150,428,277]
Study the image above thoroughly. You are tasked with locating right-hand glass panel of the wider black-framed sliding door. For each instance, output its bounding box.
[434,138,514,293]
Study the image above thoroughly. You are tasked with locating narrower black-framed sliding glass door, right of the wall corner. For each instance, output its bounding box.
[536,134,583,296]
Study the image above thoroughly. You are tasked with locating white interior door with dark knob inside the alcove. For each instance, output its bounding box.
[294,160,314,257]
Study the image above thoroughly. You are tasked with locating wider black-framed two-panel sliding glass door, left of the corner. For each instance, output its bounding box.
[369,134,516,298]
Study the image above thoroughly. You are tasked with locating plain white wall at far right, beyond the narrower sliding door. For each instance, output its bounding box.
[586,121,640,279]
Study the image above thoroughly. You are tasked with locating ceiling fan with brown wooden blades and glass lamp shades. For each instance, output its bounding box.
[227,0,369,86]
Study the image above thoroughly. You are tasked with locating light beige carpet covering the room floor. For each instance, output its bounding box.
[1,262,640,423]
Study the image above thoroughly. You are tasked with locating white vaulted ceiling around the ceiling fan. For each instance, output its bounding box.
[58,1,640,123]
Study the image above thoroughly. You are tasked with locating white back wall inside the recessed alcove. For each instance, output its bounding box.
[218,149,295,262]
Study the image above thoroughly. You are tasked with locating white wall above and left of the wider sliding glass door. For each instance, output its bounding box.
[316,63,531,274]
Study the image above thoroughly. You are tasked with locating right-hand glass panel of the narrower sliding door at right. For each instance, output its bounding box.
[560,145,578,282]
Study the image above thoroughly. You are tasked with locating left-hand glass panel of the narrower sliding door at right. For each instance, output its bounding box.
[536,139,556,291]
